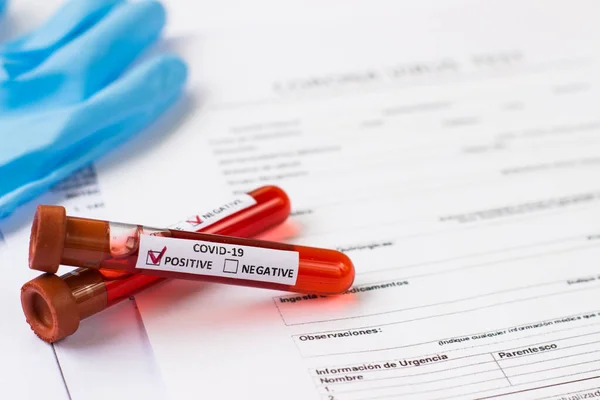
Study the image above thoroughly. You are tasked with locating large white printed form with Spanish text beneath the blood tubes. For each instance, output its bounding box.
[99,1,600,400]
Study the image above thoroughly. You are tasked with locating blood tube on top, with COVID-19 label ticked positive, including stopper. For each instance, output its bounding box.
[29,197,354,294]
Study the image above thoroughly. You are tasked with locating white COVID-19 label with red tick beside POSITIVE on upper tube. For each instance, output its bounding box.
[136,235,299,285]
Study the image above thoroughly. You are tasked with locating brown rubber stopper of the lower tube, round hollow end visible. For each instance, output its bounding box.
[21,274,79,343]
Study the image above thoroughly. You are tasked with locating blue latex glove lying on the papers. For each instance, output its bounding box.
[0,0,187,218]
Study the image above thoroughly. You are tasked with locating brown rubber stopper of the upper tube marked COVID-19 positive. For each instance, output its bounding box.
[29,205,67,274]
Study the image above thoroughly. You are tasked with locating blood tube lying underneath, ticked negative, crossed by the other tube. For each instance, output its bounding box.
[21,186,290,343]
